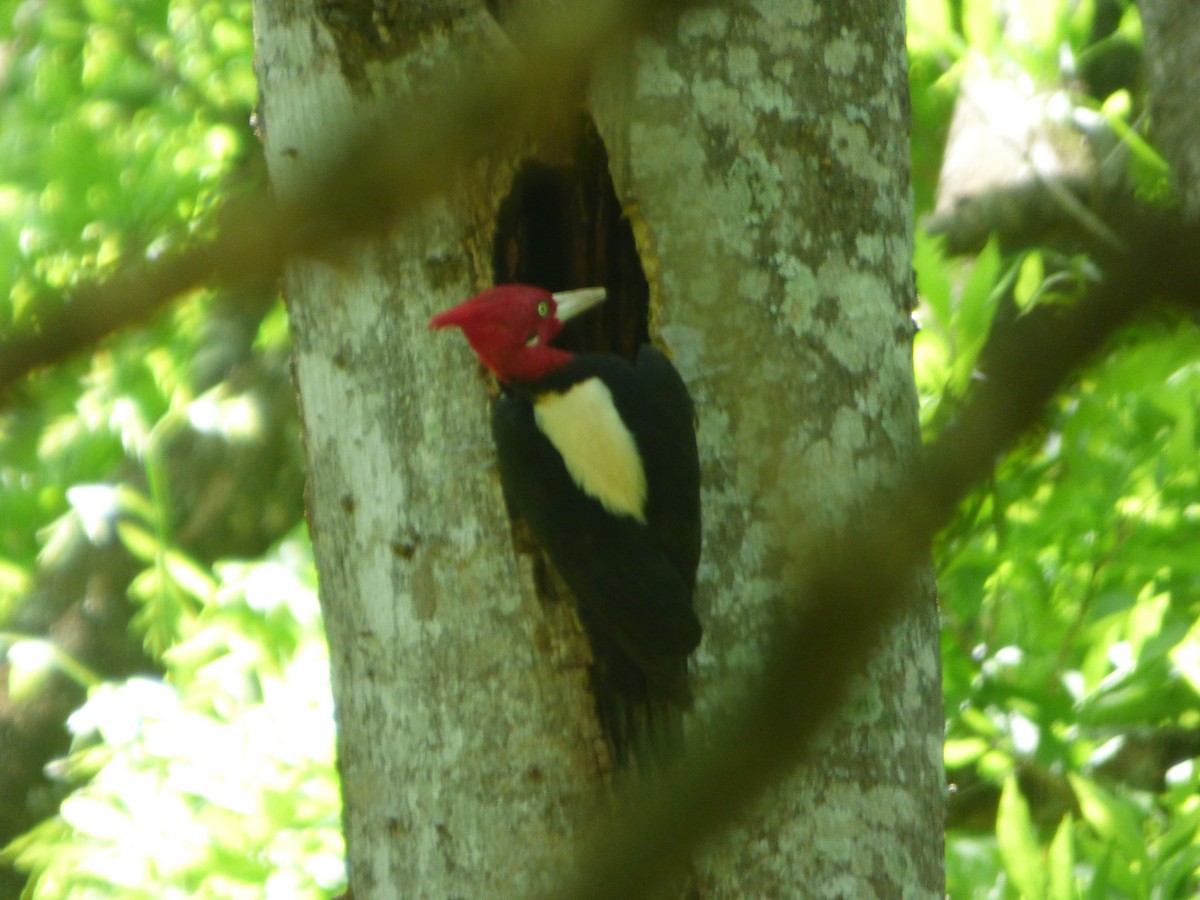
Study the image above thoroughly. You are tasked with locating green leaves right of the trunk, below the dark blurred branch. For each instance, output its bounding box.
[918,260,1200,896]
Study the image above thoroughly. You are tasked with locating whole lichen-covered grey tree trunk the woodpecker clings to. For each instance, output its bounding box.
[256,0,942,900]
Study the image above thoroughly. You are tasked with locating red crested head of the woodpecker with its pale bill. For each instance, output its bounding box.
[430,284,605,384]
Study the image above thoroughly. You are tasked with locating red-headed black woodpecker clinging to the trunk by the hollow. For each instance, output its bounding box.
[430,284,701,764]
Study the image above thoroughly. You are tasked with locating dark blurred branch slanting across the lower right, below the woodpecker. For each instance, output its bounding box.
[562,213,1200,900]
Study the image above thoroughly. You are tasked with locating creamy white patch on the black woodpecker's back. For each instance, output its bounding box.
[533,378,646,523]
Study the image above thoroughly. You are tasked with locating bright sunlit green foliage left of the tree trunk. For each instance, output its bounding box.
[0,0,328,898]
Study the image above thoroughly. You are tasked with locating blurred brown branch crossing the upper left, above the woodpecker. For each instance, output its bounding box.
[0,0,694,402]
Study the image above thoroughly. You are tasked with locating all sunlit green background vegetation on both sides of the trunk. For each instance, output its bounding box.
[0,0,1200,898]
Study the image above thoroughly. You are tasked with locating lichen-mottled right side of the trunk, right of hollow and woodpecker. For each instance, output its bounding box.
[595,0,944,896]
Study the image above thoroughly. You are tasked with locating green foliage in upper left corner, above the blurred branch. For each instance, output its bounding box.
[0,0,256,316]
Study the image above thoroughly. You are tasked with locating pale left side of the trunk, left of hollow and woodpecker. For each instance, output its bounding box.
[256,0,609,900]
